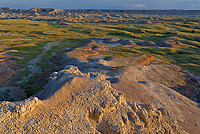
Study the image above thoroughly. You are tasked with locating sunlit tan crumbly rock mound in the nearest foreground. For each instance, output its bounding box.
[0,66,190,134]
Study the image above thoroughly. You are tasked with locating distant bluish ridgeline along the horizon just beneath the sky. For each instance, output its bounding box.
[0,7,200,15]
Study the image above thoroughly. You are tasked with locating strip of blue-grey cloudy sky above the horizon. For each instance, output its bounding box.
[0,0,200,10]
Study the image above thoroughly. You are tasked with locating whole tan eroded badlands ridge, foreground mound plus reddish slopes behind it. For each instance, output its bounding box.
[0,39,200,134]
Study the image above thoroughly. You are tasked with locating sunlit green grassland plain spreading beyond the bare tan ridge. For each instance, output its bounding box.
[0,15,200,95]
